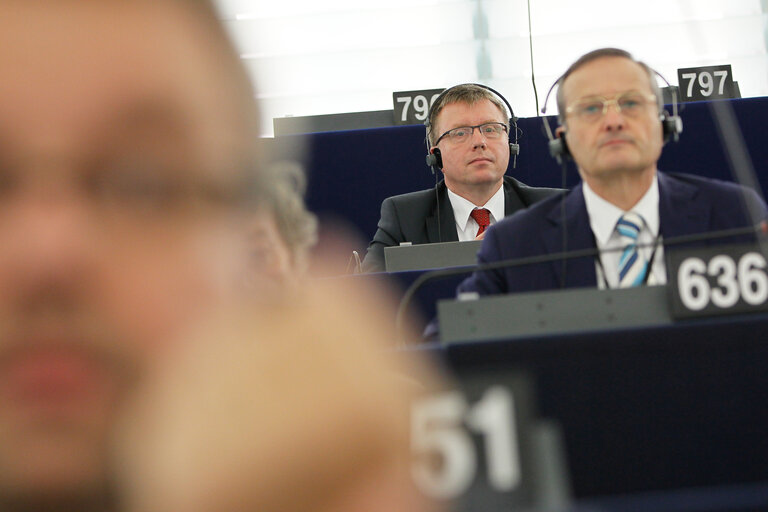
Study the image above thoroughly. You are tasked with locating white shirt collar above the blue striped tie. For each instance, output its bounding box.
[582,175,659,245]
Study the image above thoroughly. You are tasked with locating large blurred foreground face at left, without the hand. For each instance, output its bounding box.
[0,0,258,510]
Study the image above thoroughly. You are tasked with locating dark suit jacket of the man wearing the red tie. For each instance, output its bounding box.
[363,176,559,272]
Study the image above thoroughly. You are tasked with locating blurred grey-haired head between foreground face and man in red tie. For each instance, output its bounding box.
[251,161,317,283]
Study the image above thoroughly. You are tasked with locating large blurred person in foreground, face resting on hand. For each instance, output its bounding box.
[0,0,440,512]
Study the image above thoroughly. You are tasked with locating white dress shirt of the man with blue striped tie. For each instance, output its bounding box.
[582,177,667,289]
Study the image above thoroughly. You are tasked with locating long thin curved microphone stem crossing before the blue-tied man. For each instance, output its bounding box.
[395,220,768,347]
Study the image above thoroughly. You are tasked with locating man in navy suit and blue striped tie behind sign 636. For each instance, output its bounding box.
[459,48,766,295]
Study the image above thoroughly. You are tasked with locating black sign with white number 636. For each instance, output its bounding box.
[667,244,768,318]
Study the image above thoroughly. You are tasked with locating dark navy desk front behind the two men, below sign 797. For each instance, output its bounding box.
[273,98,768,251]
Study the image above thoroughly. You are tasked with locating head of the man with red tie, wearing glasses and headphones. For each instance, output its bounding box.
[427,84,510,202]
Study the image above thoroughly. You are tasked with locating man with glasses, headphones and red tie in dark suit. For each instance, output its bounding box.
[363,84,555,272]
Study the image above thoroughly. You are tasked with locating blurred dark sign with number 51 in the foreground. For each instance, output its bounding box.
[411,370,567,512]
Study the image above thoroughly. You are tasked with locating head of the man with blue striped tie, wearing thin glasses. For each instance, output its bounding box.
[557,48,663,186]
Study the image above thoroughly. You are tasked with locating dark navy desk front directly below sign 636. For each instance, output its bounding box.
[416,314,768,510]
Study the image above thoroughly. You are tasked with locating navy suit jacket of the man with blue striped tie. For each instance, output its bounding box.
[459,172,768,295]
